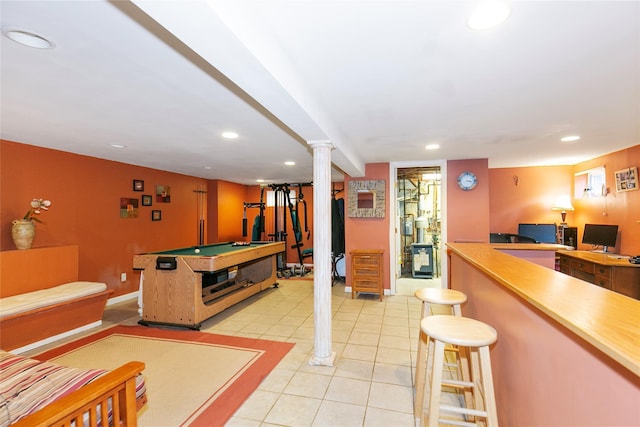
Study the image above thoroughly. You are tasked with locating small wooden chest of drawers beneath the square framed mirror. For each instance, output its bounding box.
[350,249,384,301]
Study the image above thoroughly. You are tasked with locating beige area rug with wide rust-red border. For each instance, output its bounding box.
[33,326,294,427]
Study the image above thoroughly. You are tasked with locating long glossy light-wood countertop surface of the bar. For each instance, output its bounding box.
[447,243,640,376]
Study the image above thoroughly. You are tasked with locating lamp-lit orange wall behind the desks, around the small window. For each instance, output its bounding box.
[489,145,640,255]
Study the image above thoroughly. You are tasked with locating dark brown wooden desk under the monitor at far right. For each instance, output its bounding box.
[558,251,640,299]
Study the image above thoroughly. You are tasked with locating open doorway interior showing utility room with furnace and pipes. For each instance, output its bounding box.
[392,164,443,295]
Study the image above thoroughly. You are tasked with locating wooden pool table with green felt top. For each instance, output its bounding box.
[133,242,285,330]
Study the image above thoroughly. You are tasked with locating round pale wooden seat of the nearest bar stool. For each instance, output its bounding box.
[420,315,498,347]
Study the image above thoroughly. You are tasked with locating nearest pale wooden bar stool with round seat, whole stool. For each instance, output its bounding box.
[420,315,498,427]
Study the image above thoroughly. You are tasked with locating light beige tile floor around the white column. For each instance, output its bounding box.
[27,278,450,427]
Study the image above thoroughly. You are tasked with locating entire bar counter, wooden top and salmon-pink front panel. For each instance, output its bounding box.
[447,243,640,427]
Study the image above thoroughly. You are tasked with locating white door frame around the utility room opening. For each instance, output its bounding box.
[389,160,449,295]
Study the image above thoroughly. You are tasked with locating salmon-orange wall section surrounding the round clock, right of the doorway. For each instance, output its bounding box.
[445,159,490,242]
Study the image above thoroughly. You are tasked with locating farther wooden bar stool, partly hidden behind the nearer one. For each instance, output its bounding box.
[413,288,467,418]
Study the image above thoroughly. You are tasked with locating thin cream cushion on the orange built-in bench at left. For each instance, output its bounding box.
[0,282,107,318]
